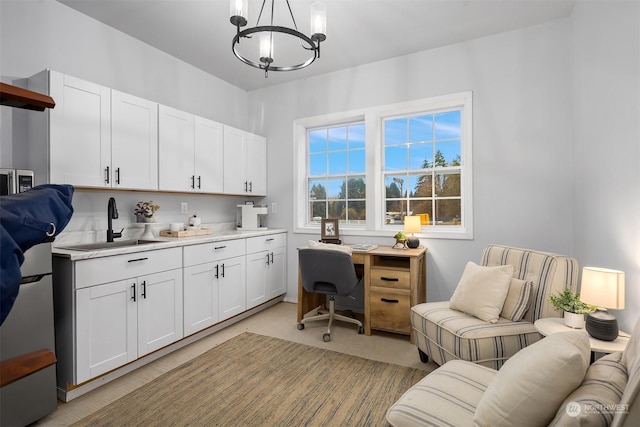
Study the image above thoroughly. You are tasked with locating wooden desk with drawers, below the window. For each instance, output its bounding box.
[298,246,427,339]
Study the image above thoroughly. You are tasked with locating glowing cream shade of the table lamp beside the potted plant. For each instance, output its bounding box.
[580,267,624,310]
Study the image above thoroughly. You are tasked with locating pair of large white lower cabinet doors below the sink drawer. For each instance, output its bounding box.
[76,269,183,383]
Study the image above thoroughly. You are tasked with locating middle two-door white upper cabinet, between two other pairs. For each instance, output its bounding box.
[159,105,223,193]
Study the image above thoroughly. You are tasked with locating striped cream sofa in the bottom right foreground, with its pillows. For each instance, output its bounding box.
[386,320,640,427]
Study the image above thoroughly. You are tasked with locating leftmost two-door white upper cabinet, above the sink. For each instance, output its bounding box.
[29,71,158,190]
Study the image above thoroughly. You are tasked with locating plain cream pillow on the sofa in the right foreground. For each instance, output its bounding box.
[473,331,591,427]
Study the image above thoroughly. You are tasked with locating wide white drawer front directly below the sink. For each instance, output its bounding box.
[75,248,182,289]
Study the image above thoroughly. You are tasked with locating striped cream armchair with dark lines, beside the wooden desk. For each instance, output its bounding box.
[411,245,578,369]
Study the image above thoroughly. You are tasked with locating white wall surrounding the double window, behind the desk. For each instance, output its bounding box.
[249,20,572,308]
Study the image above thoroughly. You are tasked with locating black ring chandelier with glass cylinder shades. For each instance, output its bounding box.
[229,0,327,78]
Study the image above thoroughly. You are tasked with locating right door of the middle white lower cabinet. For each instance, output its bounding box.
[218,256,247,321]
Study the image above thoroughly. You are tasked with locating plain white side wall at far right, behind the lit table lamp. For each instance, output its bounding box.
[572,2,640,331]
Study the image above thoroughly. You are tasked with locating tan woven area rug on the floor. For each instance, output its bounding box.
[74,332,427,426]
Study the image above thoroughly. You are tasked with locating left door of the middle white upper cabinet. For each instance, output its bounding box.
[158,105,195,191]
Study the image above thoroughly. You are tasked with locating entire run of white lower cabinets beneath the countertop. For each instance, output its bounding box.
[53,233,287,401]
